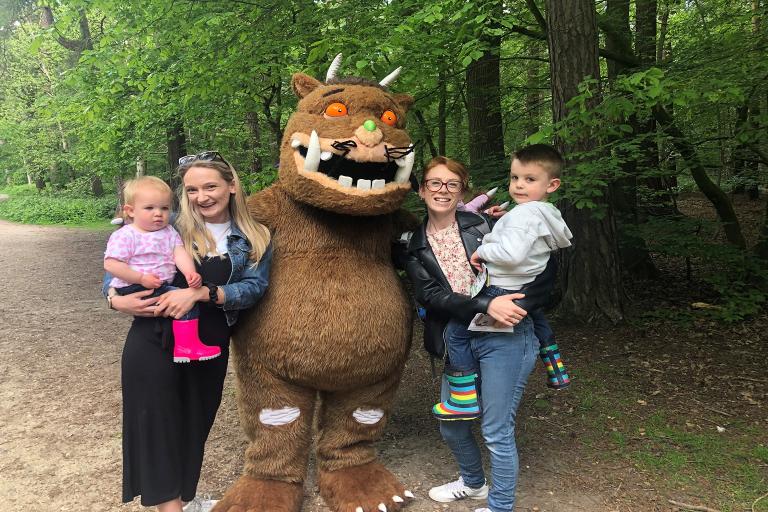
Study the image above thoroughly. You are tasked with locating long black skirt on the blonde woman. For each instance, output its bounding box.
[122,318,229,507]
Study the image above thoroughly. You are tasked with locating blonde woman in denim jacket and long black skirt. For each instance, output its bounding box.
[107,151,272,512]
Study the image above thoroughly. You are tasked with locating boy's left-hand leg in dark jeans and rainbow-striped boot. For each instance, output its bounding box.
[432,321,480,420]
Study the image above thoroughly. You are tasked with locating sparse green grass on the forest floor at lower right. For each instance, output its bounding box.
[574,365,768,512]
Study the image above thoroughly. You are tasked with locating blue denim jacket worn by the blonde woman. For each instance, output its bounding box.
[101,224,272,326]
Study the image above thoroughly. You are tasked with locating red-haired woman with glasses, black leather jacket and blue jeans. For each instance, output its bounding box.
[406,157,553,512]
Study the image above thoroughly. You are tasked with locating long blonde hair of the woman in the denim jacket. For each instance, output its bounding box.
[176,160,270,265]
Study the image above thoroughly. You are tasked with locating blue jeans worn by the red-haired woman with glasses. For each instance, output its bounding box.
[440,317,539,512]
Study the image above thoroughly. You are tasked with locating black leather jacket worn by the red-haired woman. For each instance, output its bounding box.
[405,211,557,357]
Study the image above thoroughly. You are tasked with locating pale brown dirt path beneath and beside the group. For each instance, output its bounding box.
[0,221,644,512]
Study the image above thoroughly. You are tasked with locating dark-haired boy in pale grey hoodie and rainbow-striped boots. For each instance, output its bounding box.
[432,144,572,420]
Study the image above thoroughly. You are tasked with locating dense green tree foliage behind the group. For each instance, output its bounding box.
[0,0,768,320]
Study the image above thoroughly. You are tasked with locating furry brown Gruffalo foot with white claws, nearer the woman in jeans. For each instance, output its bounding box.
[318,462,414,512]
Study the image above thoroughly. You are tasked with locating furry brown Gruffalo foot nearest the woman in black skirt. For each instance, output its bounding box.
[211,476,304,512]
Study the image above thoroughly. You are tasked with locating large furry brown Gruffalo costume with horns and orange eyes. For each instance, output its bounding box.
[214,55,414,512]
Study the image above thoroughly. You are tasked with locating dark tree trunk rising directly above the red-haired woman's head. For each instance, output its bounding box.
[467,2,505,174]
